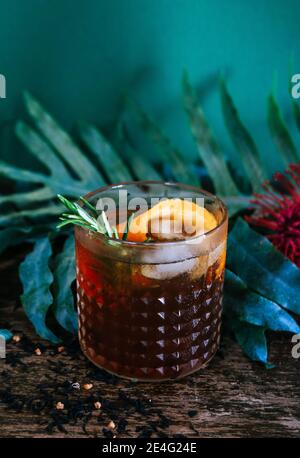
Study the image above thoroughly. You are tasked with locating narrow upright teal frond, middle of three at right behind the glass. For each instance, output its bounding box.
[220,78,267,191]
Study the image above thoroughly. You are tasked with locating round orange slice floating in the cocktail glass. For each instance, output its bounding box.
[117,199,217,242]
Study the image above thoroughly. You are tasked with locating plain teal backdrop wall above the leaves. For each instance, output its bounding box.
[0,0,300,173]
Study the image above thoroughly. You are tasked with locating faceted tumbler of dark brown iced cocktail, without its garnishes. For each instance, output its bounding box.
[75,182,227,381]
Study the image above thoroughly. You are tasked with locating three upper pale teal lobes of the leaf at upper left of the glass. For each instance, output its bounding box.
[0,93,106,203]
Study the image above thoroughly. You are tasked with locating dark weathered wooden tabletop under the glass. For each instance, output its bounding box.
[0,250,300,438]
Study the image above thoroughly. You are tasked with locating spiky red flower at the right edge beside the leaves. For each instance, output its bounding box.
[245,163,300,267]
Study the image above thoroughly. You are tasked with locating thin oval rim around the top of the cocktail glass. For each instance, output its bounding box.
[75,180,228,248]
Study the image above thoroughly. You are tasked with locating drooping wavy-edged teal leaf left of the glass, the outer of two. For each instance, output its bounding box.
[19,237,59,343]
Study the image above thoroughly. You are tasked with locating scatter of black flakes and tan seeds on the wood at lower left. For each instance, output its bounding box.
[0,334,176,438]
